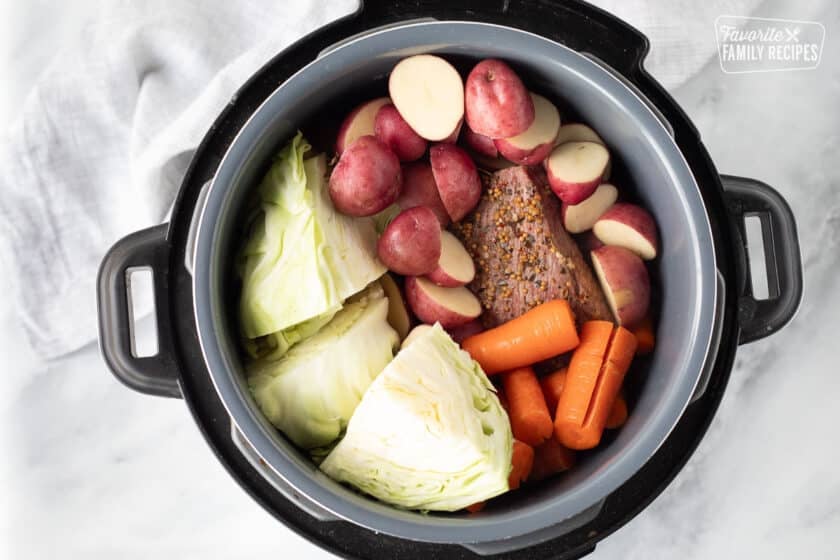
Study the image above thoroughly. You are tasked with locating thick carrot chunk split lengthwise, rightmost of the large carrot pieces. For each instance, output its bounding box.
[554,321,637,449]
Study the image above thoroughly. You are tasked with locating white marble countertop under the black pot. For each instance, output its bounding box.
[0,0,840,560]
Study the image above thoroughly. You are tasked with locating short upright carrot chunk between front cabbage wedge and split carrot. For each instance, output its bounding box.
[502,367,554,445]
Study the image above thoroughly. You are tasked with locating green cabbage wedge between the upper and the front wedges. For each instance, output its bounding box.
[246,283,399,449]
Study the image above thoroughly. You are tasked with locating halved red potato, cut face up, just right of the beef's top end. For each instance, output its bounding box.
[543,142,610,204]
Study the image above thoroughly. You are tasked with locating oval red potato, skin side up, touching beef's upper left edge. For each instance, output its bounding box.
[429,144,481,222]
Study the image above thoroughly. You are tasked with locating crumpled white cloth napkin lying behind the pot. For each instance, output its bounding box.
[0,0,758,358]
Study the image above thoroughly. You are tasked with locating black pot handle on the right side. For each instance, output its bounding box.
[721,175,802,344]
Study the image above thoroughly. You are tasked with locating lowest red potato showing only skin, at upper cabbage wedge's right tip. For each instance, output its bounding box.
[376,206,440,274]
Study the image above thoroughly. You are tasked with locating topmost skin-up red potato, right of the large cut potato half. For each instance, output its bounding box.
[464,58,534,139]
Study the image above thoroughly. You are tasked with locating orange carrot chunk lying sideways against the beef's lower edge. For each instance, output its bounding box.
[461,299,579,375]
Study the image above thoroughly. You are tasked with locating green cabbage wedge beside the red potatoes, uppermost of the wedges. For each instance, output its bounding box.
[240,133,385,342]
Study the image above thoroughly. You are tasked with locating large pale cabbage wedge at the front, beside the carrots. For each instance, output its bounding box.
[320,325,513,511]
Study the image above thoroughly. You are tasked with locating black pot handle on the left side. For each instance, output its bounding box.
[97,224,181,397]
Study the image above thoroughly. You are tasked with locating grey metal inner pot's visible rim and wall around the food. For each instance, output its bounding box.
[193,21,723,553]
